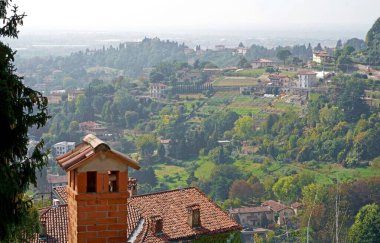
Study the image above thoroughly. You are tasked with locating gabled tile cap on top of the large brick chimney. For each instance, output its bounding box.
[56,134,140,171]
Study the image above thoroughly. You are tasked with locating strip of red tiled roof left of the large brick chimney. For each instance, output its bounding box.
[30,205,68,243]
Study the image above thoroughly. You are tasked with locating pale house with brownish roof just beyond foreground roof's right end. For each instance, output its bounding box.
[229,206,275,228]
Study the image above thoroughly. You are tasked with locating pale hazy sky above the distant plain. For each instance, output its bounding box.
[17,0,380,33]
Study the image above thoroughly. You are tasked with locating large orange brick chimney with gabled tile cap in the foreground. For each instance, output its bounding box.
[57,134,140,243]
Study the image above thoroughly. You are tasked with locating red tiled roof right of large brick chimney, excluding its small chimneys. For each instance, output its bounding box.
[128,188,240,242]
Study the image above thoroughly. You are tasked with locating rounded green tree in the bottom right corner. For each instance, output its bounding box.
[349,204,380,243]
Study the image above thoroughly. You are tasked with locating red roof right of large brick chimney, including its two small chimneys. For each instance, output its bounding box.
[127,187,241,242]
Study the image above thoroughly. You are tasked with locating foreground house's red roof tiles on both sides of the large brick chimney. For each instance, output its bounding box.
[31,187,241,243]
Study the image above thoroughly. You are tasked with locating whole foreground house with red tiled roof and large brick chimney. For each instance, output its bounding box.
[31,135,241,242]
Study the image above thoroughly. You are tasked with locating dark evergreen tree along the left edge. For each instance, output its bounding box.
[0,0,49,241]
